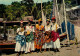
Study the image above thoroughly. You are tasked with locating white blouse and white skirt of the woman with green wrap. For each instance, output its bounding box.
[25,26,35,53]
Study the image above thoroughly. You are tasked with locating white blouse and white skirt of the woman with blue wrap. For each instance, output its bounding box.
[15,27,25,52]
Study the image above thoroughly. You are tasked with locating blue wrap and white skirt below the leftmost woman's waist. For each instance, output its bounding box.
[15,35,26,52]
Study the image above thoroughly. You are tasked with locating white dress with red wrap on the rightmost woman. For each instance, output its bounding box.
[51,23,60,48]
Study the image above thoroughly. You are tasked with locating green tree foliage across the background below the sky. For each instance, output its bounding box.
[0,0,77,20]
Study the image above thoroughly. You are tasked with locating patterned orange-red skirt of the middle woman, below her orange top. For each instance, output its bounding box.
[34,31,44,49]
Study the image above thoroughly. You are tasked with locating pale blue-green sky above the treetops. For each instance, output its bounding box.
[0,0,51,5]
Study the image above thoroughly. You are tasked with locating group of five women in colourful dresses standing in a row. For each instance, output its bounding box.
[15,17,60,53]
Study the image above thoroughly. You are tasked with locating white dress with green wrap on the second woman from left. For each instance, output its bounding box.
[25,26,35,53]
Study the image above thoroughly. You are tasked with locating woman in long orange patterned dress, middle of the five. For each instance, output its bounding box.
[35,19,44,52]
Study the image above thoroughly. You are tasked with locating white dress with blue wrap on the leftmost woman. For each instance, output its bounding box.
[15,27,26,52]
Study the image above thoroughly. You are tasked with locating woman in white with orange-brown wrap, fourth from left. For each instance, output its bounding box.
[42,19,52,51]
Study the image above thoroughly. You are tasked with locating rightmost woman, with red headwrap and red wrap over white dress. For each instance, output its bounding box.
[51,17,60,52]
